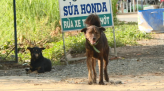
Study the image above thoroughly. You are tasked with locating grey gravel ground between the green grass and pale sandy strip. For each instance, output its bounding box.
[0,35,164,83]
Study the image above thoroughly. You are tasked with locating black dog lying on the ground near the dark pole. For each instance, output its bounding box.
[26,47,52,73]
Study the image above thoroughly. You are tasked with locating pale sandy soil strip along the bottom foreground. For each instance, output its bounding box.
[0,74,164,91]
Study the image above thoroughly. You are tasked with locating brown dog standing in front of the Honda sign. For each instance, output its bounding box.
[81,14,109,85]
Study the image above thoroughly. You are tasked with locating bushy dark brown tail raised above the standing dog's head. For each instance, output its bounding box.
[85,14,101,27]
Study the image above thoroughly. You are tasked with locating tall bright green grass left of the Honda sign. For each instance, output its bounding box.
[0,0,60,45]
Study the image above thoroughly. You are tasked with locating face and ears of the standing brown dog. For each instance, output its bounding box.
[81,25,105,45]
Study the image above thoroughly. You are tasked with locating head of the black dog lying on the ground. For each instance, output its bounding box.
[27,47,45,59]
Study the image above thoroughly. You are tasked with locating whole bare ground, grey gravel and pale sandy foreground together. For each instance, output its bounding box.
[0,34,164,91]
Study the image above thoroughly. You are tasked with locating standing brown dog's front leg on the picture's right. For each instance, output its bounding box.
[98,58,104,85]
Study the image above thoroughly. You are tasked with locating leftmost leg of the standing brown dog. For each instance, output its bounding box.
[87,57,93,85]
